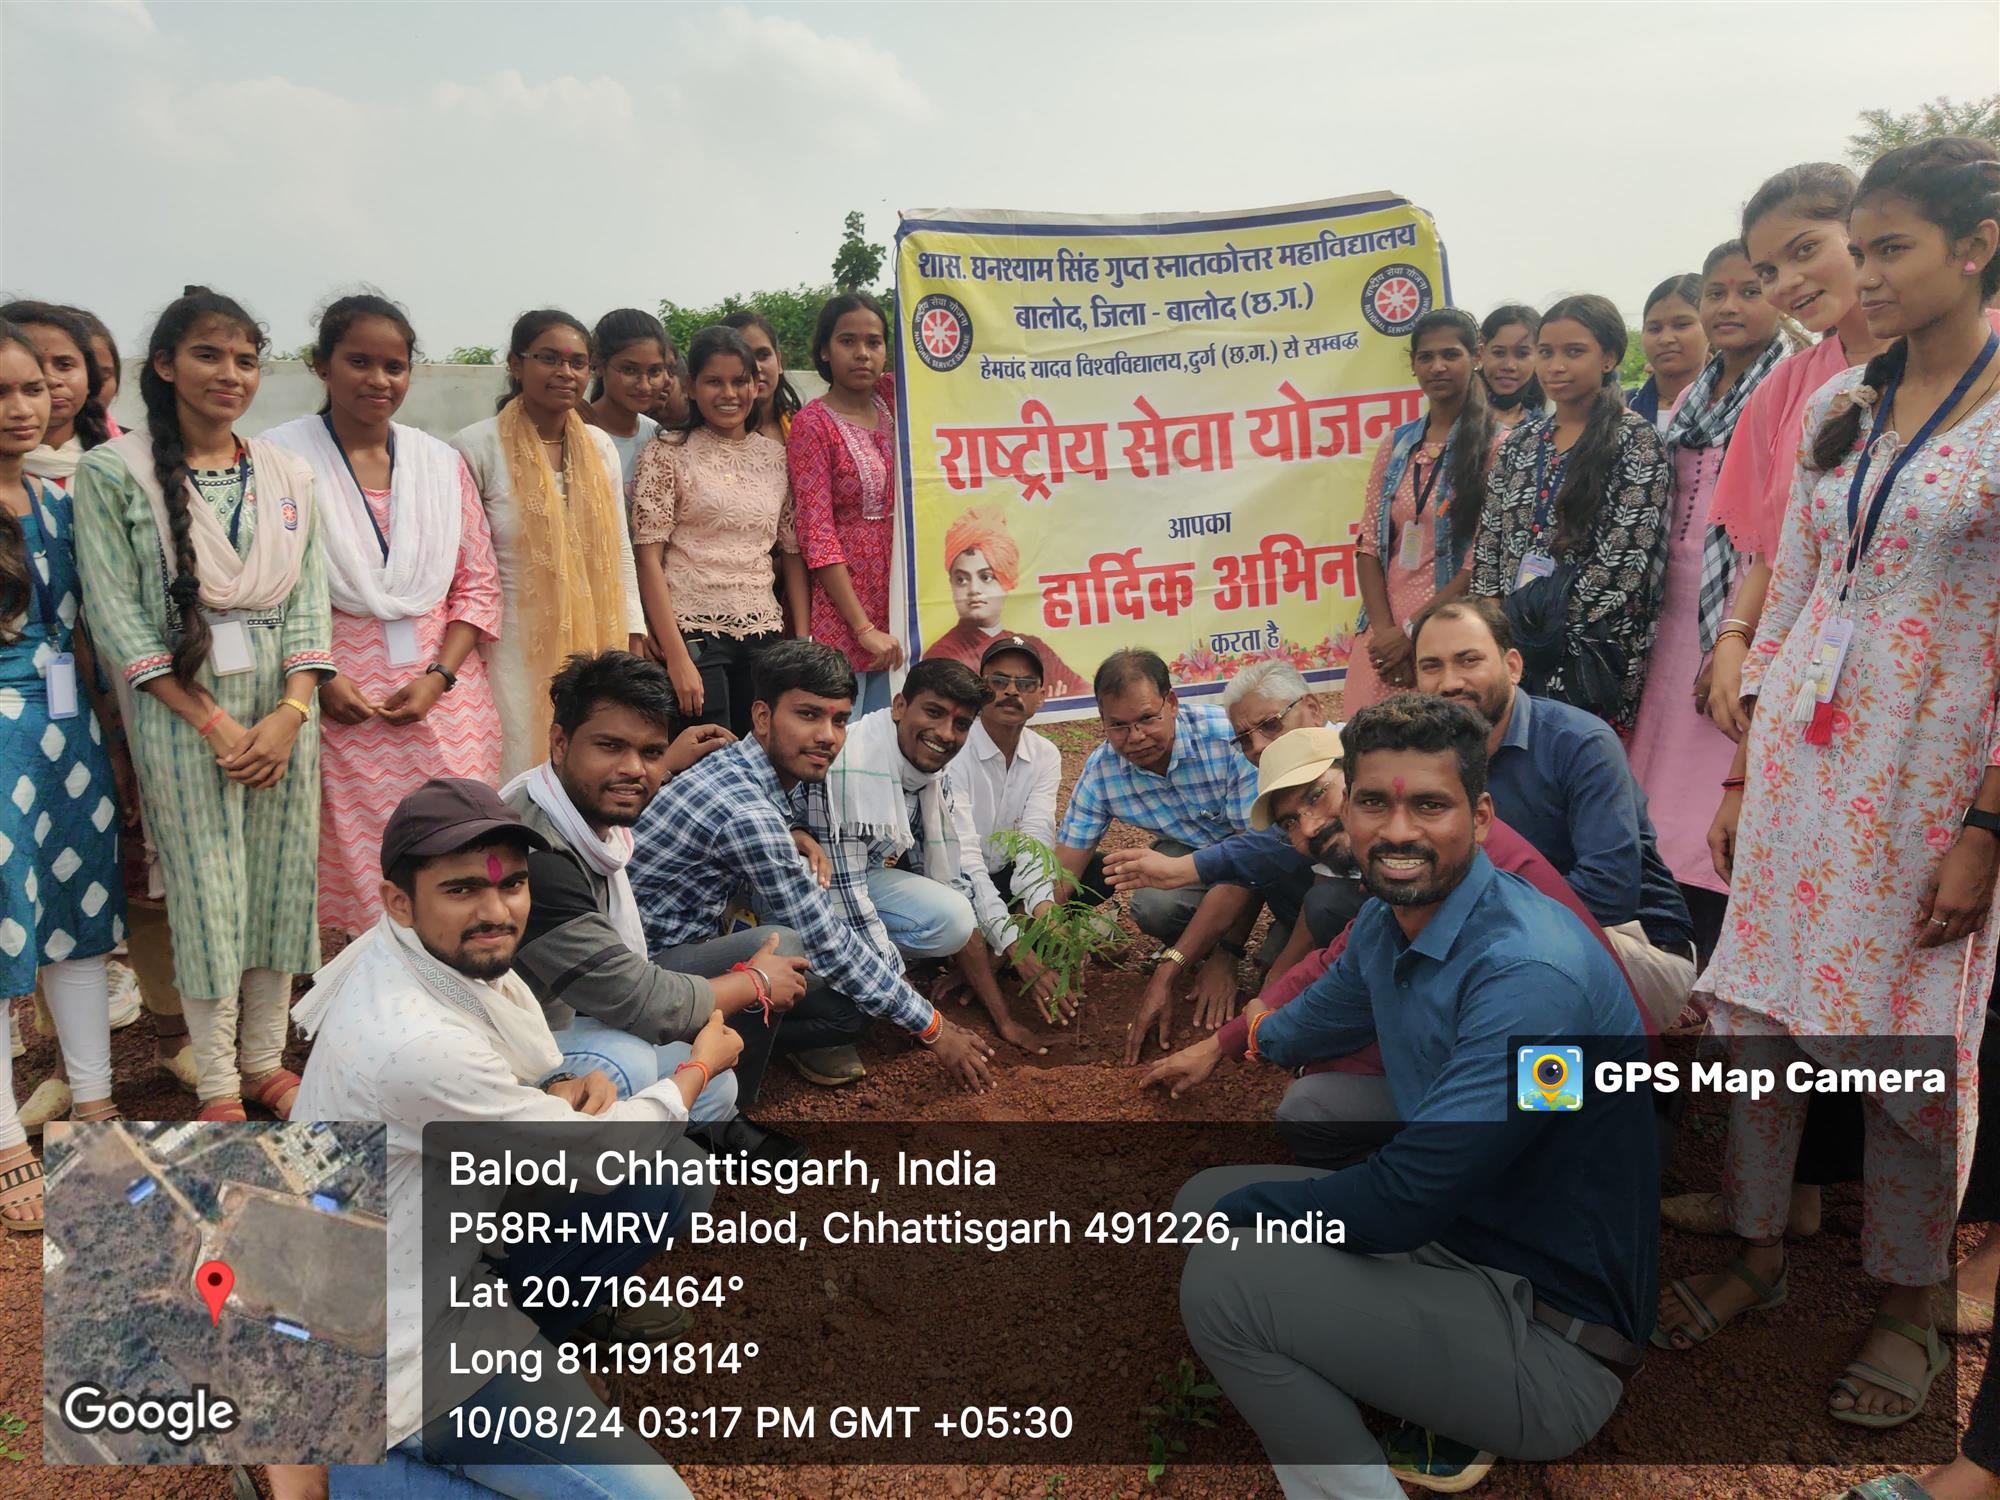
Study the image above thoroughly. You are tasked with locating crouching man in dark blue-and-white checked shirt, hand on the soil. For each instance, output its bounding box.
[630,640,992,1090]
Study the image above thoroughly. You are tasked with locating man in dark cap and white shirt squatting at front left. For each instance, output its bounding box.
[292,780,742,1494]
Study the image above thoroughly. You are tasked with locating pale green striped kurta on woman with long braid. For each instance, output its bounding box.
[72,448,334,1000]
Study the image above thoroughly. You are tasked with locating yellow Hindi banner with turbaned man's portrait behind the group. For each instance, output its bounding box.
[896,192,1450,718]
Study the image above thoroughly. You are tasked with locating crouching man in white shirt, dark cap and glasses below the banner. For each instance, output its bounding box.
[932,634,1110,1052]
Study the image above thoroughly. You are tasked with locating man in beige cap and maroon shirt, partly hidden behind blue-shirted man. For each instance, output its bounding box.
[1140,728,1652,1168]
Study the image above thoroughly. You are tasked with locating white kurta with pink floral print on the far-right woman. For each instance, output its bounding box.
[1700,370,2000,1170]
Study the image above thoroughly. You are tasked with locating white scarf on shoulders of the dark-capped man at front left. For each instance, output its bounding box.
[292,912,562,1086]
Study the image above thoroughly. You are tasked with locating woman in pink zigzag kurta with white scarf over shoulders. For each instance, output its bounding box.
[264,296,502,934]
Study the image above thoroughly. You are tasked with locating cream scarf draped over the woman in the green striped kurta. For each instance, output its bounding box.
[104,432,312,612]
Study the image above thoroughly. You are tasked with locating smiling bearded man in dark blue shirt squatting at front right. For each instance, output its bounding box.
[1174,694,1660,1500]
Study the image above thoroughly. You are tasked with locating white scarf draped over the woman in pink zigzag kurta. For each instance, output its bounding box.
[264,416,462,620]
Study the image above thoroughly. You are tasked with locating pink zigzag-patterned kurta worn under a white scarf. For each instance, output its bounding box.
[320,460,500,934]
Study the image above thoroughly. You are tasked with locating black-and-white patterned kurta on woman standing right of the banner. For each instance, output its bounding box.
[1470,412,1670,734]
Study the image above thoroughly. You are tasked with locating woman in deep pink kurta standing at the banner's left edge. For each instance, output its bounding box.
[786,292,902,718]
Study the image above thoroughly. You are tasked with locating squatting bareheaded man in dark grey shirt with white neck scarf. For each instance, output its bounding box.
[500,650,806,1152]
